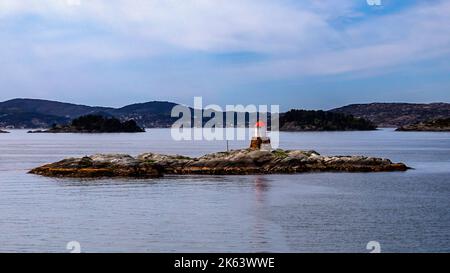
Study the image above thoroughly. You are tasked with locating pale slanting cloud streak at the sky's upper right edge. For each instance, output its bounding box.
[227,2,450,77]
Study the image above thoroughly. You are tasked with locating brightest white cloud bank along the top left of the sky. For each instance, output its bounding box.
[0,0,336,52]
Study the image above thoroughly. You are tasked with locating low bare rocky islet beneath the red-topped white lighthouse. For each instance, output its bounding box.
[30,149,408,178]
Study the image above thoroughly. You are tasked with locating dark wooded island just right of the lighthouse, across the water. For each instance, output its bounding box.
[280,110,377,131]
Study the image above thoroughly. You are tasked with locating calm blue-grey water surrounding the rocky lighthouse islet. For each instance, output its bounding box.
[0,129,450,252]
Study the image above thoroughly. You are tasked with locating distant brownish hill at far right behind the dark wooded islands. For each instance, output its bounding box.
[330,103,450,127]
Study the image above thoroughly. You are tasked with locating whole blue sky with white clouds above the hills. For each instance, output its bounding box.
[0,0,450,110]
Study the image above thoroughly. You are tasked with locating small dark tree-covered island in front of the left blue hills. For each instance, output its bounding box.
[29,115,145,133]
